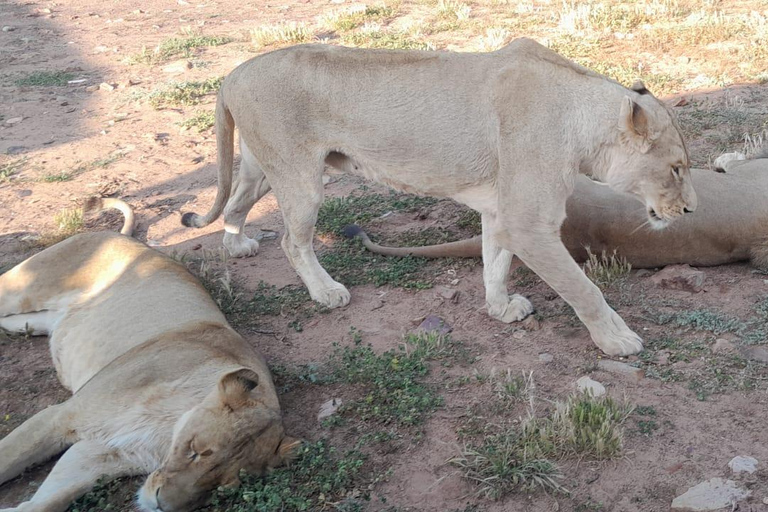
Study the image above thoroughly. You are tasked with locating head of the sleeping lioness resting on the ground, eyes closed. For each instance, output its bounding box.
[138,368,300,512]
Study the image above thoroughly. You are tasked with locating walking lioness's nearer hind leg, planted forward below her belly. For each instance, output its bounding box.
[268,162,350,308]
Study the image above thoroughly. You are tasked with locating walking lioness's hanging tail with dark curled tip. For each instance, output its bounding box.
[181,91,235,228]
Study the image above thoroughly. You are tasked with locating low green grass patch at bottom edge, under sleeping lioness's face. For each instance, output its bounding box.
[206,440,369,512]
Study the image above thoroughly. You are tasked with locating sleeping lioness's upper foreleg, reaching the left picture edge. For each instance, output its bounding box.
[0,402,73,484]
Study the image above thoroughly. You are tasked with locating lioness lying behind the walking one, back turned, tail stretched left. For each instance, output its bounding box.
[345,157,768,269]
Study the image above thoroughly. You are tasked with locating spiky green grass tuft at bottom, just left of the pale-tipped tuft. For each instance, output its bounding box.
[449,431,563,499]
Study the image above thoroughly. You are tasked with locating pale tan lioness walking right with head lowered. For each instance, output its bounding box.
[182,39,696,355]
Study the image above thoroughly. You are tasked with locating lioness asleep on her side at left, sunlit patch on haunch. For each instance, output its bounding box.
[0,200,298,512]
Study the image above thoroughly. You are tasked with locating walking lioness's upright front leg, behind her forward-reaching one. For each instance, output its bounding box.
[482,213,533,323]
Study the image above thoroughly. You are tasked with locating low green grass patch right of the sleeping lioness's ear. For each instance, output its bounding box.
[331,334,448,427]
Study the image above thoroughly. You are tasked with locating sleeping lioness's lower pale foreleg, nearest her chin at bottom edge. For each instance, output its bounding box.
[0,441,138,512]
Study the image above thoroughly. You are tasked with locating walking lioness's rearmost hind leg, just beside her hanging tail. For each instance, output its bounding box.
[224,140,271,258]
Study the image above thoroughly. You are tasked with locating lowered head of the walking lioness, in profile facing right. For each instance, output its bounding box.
[605,82,697,229]
